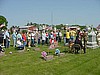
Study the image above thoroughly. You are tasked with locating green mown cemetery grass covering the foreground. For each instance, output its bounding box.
[0,41,100,75]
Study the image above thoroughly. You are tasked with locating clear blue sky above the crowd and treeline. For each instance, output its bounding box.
[0,0,100,27]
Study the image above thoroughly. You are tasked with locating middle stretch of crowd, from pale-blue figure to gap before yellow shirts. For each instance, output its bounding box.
[12,30,62,47]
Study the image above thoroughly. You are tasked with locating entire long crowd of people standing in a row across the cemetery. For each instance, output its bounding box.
[0,27,87,53]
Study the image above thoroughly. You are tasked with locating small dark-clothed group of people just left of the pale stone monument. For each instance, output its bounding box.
[67,30,88,53]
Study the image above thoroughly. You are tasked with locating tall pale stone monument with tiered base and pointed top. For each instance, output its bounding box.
[87,26,98,49]
